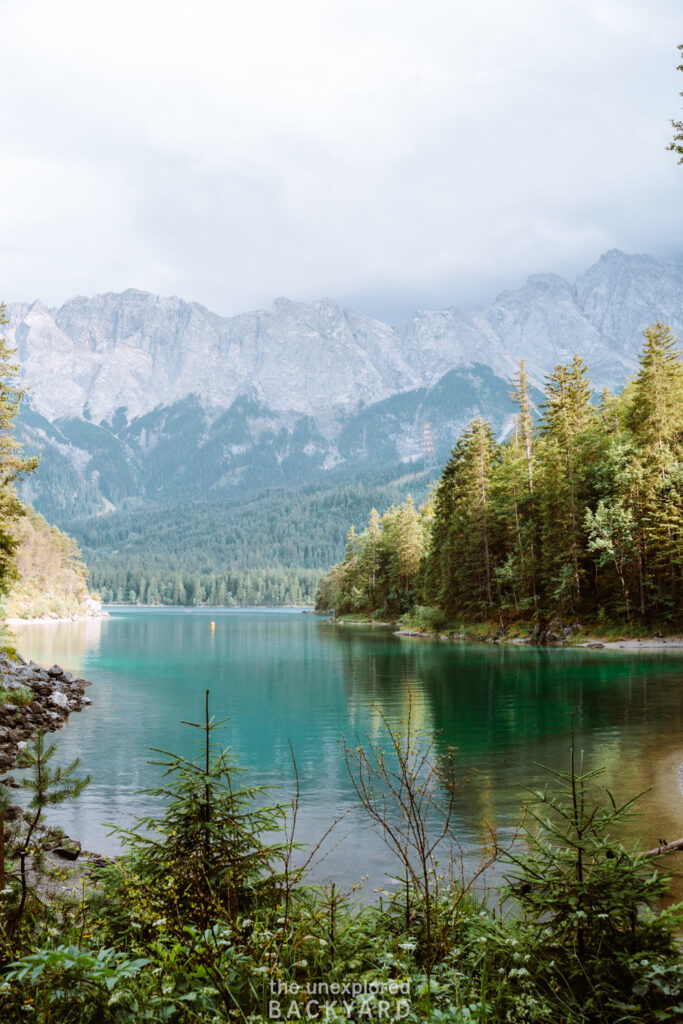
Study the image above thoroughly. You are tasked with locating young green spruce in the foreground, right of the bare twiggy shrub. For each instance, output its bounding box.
[503,722,683,1024]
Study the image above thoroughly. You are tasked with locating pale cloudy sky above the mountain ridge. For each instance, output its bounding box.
[0,0,683,322]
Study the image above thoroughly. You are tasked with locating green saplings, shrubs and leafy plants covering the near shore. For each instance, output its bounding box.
[0,700,683,1024]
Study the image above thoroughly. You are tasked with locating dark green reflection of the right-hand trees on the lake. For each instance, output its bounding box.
[334,629,683,840]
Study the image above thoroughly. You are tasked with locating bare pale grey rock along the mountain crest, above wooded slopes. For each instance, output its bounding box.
[8,251,683,423]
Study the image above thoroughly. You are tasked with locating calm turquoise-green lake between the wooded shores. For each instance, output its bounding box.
[7,608,683,901]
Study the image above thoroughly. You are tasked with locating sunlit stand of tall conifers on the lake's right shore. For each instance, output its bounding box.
[316,323,683,627]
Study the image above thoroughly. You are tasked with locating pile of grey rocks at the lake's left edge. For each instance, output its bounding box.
[0,653,92,771]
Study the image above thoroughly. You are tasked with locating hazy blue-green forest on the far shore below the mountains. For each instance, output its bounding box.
[80,467,427,606]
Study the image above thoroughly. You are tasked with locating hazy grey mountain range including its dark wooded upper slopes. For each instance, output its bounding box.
[6,243,683,526]
